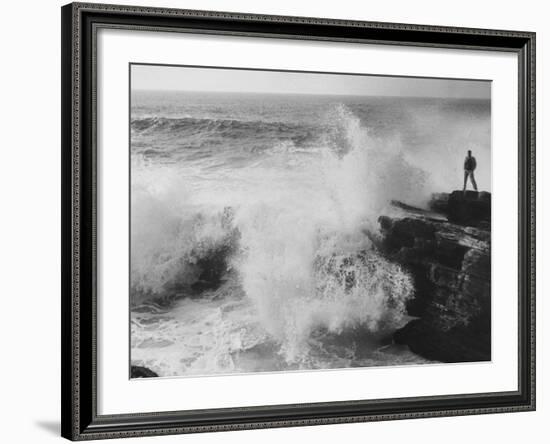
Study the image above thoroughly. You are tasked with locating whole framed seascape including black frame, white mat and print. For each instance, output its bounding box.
[61,3,535,440]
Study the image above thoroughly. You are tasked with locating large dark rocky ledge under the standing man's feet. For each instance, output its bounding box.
[379,191,491,362]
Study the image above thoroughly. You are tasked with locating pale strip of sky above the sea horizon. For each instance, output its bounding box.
[131,64,491,99]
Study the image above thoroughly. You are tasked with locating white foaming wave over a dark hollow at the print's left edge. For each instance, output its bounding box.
[131,156,242,304]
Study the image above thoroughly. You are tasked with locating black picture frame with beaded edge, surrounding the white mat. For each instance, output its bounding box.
[61,3,535,440]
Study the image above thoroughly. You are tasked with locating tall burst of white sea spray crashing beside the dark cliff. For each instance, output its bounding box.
[229,107,413,362]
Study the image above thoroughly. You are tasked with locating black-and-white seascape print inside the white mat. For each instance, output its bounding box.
[129,64,491,378]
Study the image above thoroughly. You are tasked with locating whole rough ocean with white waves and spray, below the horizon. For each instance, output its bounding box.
[130,91,491,376]
